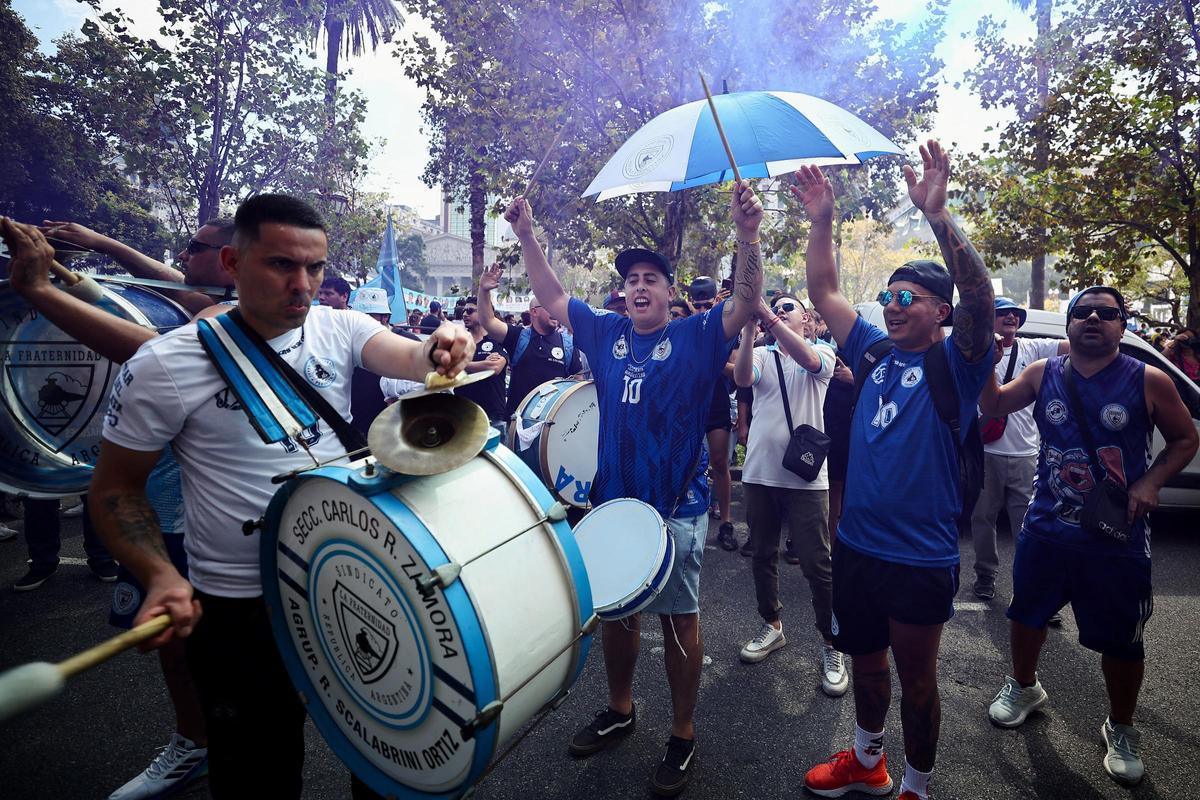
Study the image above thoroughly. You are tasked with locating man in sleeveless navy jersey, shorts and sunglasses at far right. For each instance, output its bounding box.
[979,287,1196,786]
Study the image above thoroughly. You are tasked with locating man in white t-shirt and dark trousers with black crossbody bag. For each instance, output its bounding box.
[733,294,848,697]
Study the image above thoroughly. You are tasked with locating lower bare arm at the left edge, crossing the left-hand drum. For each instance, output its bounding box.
[0,218,157,363]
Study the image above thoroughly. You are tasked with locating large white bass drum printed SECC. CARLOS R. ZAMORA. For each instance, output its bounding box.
[262,433,593,798]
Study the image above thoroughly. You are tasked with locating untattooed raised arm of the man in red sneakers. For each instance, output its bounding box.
[792,167,858,345]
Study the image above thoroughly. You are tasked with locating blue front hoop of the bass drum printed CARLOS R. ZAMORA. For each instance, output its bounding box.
[259,467,499,798]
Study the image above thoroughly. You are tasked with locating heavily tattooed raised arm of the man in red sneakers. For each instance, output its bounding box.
[904,139,996,361]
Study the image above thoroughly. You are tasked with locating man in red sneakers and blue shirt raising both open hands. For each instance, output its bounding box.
[793,142,995,800]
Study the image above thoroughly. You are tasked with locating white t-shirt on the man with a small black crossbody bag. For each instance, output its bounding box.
[742,342,836,489]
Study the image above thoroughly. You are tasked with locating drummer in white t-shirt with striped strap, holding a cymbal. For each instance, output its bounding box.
[91,194,473,798]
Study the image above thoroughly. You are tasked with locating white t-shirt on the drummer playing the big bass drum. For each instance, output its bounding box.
[103,306,386,597]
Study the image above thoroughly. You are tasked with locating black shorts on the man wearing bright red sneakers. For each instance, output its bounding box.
[833,540,959,656]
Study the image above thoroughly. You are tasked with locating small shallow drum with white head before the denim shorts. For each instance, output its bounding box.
[575,498,674,620]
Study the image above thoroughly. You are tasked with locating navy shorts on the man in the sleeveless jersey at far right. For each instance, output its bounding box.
[1008,534,1154,661]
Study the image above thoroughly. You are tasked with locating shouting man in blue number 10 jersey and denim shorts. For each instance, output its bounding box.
[505,182,762,795]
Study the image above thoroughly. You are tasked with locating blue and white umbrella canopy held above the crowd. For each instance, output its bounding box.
[583,91,901,200]
